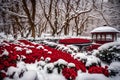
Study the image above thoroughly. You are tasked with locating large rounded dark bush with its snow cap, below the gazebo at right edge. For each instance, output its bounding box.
[97,42,120,63]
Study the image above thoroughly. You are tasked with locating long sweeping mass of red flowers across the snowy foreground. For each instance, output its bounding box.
[0,39,109,80]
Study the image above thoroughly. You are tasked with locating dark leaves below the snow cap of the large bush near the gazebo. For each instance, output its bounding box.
[98,46,120,64]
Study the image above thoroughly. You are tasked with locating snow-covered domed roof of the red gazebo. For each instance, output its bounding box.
[91,26,120,33]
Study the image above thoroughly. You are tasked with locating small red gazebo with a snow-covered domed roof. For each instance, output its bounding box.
[91,26,119,44]
